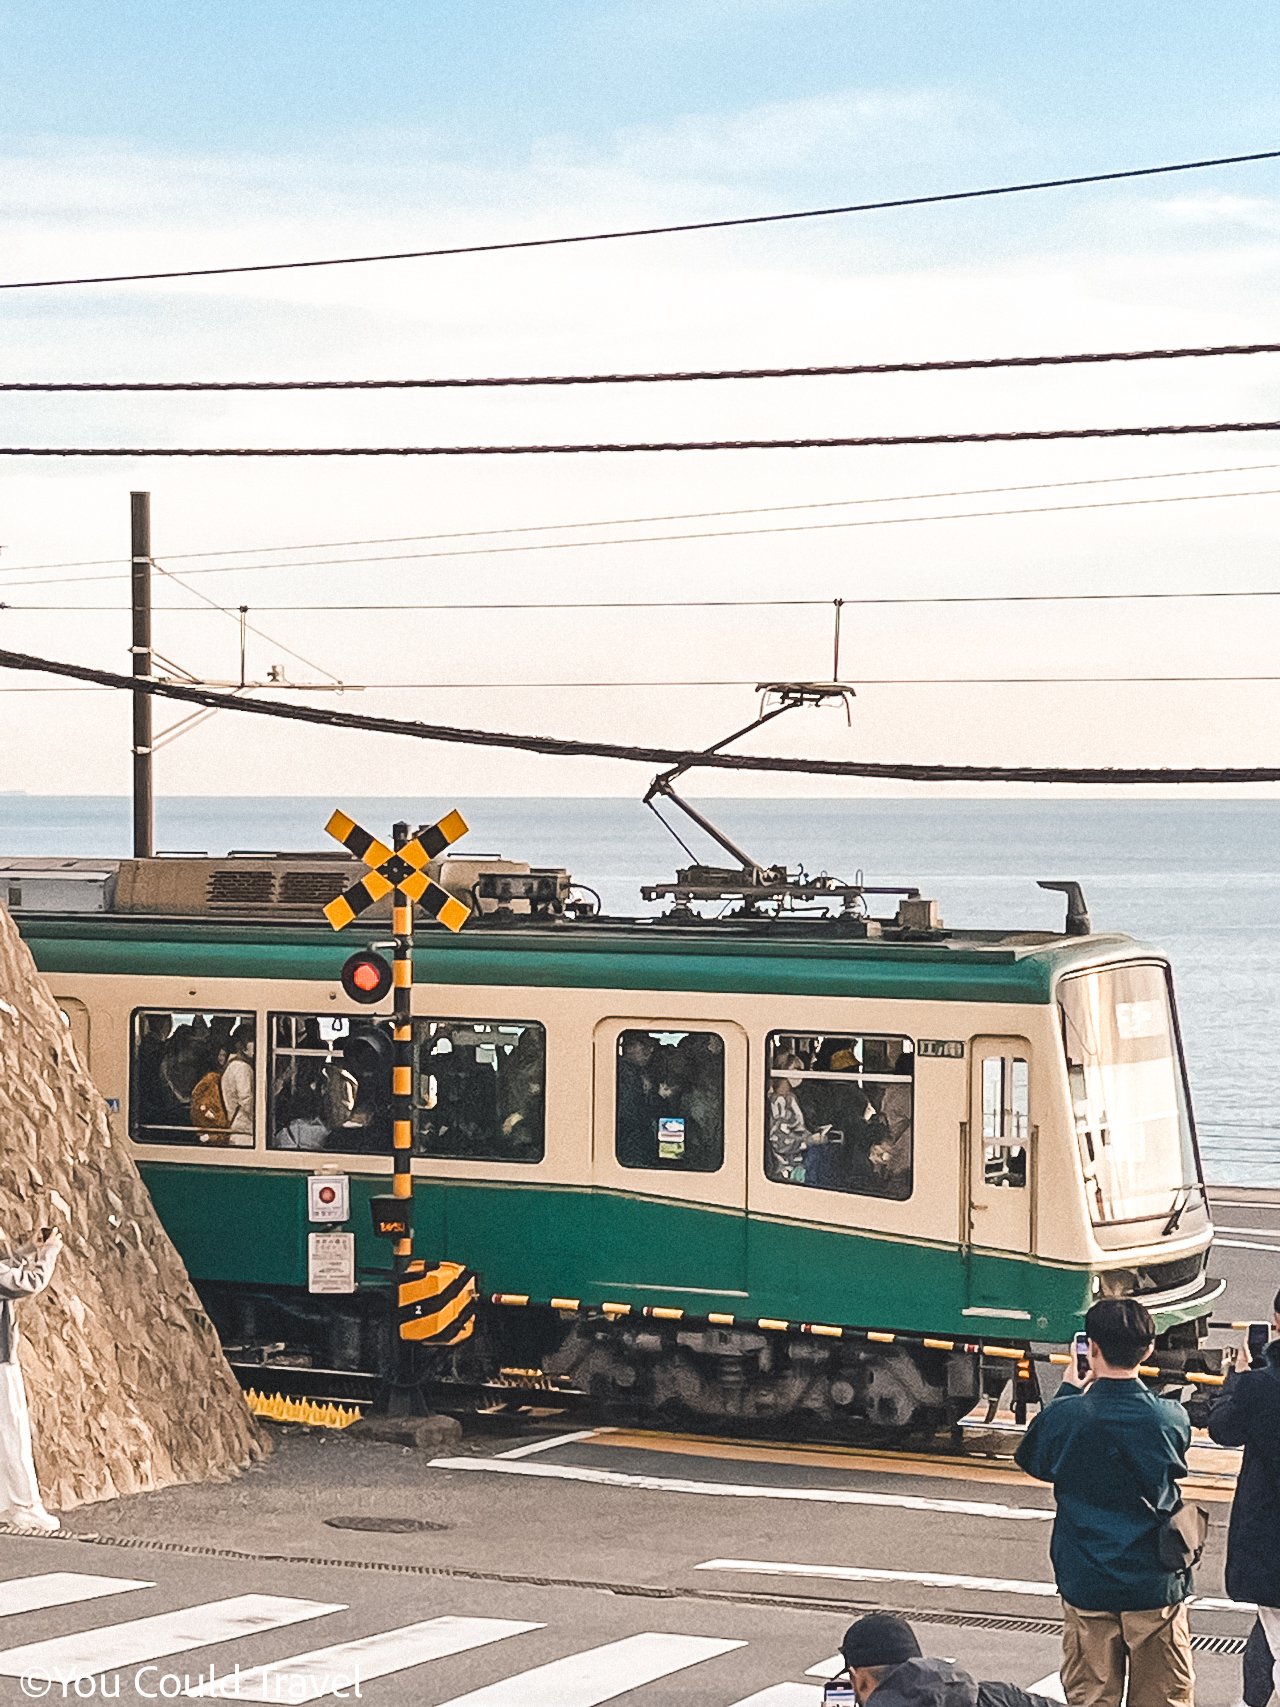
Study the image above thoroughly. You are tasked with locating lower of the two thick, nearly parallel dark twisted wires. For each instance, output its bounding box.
[0,422,1280,459]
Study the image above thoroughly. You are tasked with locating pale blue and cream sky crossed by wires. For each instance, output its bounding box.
[0,0,1280,797]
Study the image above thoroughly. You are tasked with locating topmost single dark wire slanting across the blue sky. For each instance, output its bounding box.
[0,149,1280,290]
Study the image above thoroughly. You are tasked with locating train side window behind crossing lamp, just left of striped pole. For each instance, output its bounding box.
[266,1014,394,1156]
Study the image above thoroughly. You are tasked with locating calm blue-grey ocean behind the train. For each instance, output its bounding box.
[0,794,1280,1186]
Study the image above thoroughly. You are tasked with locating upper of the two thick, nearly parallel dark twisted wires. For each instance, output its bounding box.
[0,343,1280,393]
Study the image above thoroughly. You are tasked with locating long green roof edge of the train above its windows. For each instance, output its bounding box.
[12,891,1162,1002]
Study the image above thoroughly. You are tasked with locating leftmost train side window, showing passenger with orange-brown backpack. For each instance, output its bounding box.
[130,1007,254,1147]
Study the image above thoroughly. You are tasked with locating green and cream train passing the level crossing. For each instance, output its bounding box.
[0,855,1222,1427]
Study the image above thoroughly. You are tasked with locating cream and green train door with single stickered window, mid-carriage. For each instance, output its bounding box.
[587,1017,748,1309]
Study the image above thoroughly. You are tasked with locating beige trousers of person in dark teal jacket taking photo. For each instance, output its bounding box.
[1062,1601,1196,1707]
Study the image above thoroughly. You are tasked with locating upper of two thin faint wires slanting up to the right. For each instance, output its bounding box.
[0,463,1280,575]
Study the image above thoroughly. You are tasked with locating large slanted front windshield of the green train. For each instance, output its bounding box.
[1058,961,1198,1226]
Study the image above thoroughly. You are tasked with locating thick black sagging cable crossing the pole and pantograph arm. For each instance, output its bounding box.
[0,650,1280,785]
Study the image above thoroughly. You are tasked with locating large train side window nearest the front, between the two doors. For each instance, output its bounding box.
[765,1031,915,1202]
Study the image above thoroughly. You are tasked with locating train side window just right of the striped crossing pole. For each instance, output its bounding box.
[413,1019,546,1162]
